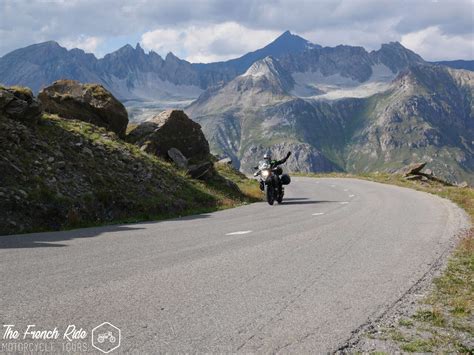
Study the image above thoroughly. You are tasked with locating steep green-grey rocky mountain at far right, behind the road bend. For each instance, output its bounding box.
[346,65,474,182]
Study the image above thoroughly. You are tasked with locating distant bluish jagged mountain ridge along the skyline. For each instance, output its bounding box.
[0,31,436,101]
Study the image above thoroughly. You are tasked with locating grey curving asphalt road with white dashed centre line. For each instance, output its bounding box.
[0,178,467,353]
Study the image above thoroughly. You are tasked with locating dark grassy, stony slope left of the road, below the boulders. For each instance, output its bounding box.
[0,115,257,235]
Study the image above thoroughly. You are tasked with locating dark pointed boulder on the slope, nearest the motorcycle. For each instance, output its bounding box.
[127,110,209,163]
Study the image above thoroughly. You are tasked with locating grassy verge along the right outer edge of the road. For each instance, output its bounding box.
[298,173,474,353]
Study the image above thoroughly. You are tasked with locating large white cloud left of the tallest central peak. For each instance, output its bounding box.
[141,22,281,63]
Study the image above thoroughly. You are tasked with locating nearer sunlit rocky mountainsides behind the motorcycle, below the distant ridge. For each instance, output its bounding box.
[187,57,474,181]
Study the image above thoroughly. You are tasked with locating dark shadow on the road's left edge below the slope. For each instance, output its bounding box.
[0,225,144,249]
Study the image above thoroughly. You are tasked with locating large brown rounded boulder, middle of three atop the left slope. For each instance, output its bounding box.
[38,80,128,137]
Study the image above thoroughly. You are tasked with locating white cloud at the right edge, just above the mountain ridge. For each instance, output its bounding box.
[401,26,474,60]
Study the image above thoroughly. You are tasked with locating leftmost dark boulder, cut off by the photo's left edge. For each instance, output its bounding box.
[0,86,42,123]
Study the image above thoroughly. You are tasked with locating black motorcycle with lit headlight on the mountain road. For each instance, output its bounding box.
[254,160,290,205]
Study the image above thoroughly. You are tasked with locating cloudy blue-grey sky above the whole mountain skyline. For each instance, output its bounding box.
[0,0,474,62]
